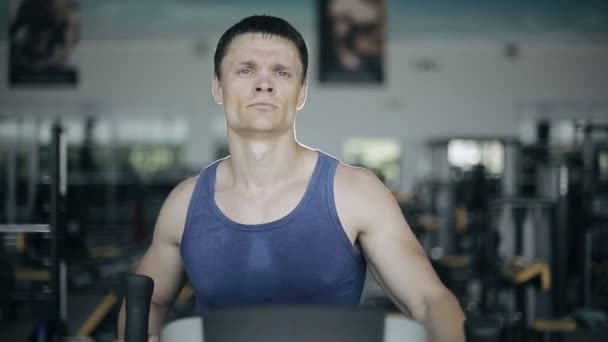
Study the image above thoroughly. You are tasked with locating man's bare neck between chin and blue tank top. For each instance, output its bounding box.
[227,130,302,194]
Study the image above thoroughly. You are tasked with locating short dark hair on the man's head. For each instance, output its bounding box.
[213,15,308,82]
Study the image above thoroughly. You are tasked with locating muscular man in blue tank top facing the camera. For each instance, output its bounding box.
[119,16,464,341]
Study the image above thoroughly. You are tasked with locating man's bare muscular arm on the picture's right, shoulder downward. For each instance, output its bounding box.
[336,166,464,342]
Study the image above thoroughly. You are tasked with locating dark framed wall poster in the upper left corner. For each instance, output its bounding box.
[8,0,80,87]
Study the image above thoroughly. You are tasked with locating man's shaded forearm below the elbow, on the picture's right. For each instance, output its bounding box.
[421,292,465,342]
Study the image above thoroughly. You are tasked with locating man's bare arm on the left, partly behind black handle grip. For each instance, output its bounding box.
[118,180,195,341]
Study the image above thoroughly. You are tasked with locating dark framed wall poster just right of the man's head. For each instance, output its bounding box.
[318,0,386,83]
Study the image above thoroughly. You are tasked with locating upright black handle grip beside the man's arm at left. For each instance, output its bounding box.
[125,274,154,342]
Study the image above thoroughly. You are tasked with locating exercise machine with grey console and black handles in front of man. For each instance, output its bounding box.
[125,274,499,342]
